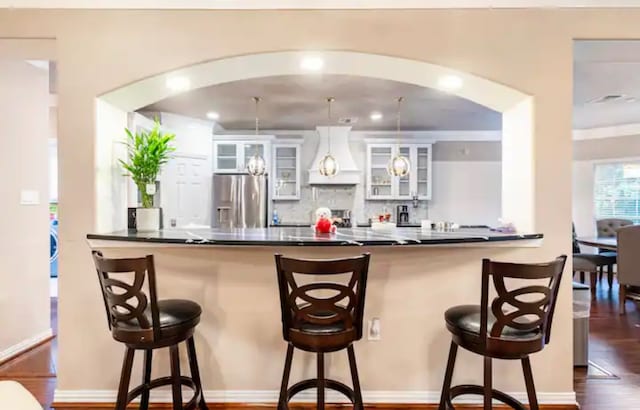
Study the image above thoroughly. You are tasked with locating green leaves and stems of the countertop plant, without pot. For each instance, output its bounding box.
[120,120,176,208]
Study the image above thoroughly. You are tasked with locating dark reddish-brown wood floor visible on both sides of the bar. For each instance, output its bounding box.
[0,280,640,410]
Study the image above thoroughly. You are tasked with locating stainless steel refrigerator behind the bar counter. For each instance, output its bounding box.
[211,174,268,228]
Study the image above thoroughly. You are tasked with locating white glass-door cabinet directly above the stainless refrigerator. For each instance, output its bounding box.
[213,140,270,173]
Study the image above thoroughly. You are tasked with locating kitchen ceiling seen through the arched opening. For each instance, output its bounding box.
[140,75,502,131]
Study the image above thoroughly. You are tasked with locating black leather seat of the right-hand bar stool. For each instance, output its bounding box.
[444,305,540,341]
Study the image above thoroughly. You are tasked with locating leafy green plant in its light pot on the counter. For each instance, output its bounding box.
[120,120,175,232]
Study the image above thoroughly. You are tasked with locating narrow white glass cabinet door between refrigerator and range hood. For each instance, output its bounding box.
[272,144,300,200]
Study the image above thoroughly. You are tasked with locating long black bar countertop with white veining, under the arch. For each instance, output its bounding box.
[87,227,543,246]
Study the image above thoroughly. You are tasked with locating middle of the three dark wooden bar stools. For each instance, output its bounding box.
[275,253,369,410]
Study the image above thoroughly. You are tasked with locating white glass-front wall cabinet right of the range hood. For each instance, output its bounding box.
[366,143,432,200]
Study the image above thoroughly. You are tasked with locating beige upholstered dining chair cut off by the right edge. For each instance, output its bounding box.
[617,225,640,315]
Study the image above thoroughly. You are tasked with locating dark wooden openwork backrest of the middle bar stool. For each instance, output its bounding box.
[275,253,370,341]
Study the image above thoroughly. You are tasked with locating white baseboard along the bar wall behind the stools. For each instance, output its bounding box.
[53,389,576,405]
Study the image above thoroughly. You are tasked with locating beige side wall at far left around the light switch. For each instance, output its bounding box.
[0,59,50,359]
